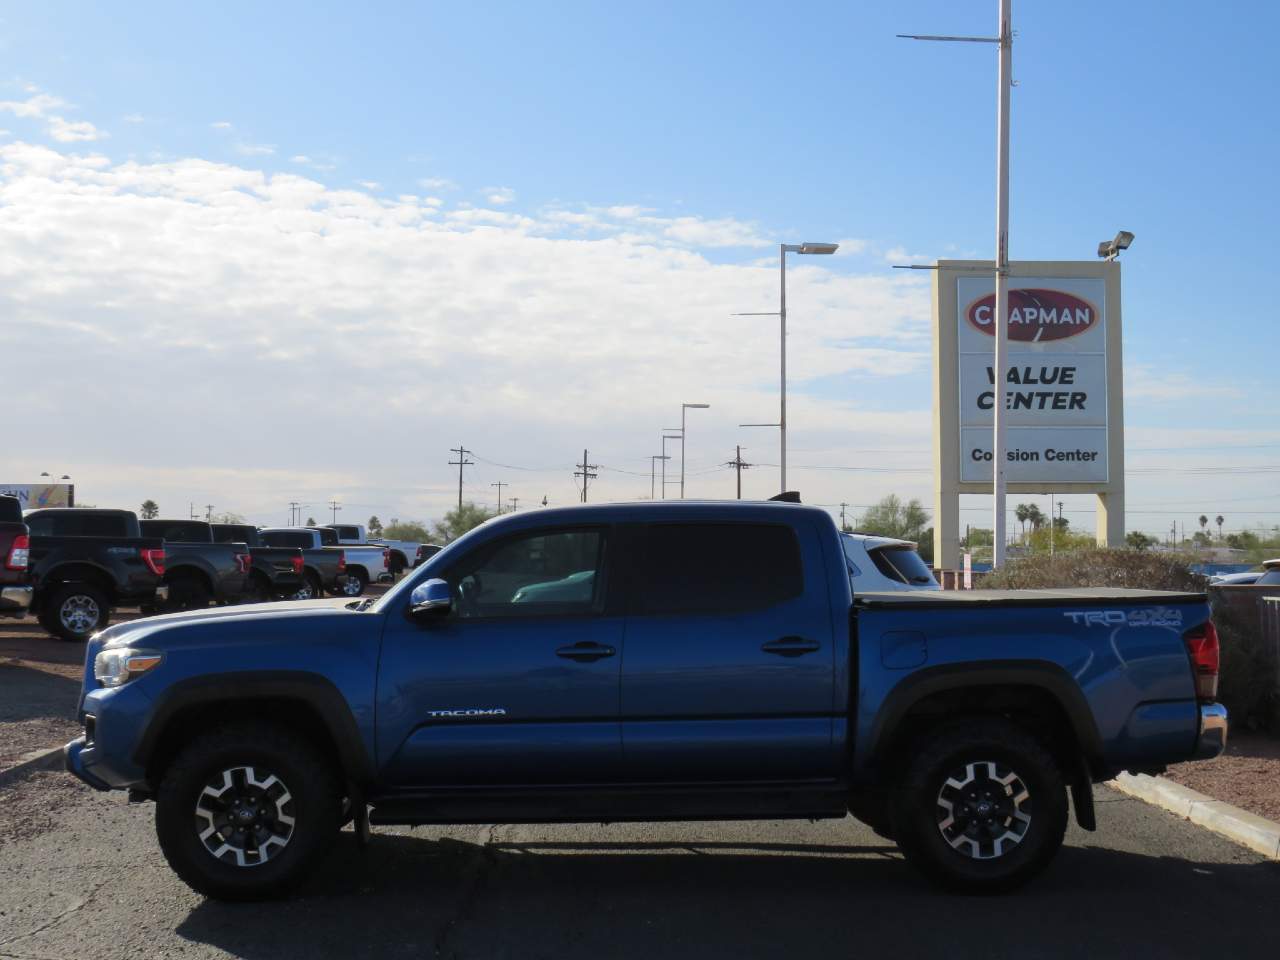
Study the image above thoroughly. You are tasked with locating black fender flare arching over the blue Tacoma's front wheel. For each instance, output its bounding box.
[133,671,374,783]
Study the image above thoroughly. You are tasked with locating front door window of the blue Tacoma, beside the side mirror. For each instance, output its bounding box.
[447,530,604,618]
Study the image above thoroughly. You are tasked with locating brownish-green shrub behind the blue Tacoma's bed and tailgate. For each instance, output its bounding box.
[982,549,1280,730]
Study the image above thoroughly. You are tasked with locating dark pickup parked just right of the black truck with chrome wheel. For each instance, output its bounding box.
[138,520,250,611]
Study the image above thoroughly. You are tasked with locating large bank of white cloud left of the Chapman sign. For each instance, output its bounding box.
[0,143,929,520]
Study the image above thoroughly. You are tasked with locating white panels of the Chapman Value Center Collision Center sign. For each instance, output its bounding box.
[955,274,1108,484]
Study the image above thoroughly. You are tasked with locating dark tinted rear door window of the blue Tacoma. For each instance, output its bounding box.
[637,524,804,613]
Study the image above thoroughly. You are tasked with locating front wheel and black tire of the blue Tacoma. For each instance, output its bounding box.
[156,722,343,900]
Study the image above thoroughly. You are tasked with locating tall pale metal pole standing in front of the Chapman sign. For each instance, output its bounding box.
[991,0,1014,568]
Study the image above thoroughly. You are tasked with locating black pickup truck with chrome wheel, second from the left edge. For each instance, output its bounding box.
[26,507,169,640]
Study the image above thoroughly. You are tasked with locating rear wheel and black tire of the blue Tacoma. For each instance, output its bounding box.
[892,718,1068,893]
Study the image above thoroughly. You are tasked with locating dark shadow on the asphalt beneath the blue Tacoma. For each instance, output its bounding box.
[177,831,1280,960]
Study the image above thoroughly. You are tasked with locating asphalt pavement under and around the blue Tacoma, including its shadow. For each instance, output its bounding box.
[0,773,1280,960]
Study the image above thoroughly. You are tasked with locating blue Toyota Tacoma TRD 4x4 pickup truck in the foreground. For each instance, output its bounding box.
[65,502,1226,900]
